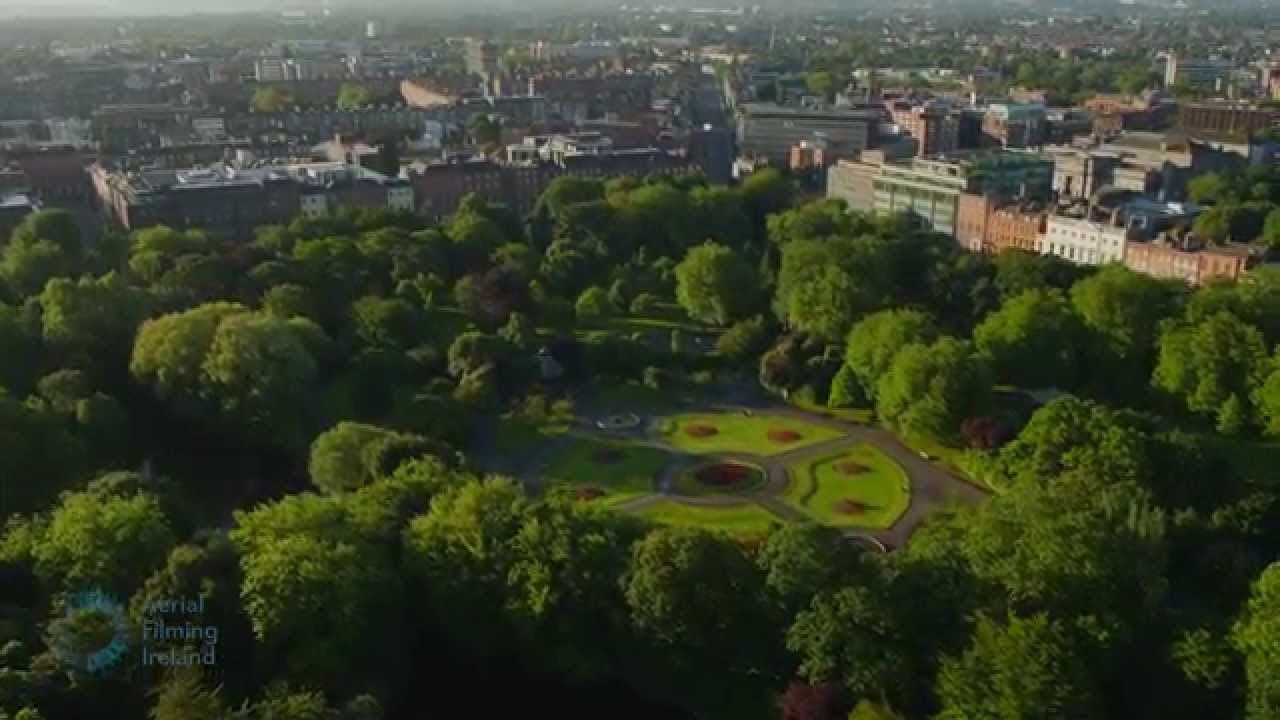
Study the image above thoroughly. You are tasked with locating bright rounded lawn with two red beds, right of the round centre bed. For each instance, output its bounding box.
[782,445,911,528]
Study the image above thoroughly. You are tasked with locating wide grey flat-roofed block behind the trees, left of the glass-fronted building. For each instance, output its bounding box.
[737,104,879,167]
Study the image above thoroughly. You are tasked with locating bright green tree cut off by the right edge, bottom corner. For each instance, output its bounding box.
[1231,562,1280,720]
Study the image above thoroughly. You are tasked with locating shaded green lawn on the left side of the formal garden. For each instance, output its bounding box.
[543,436,672,505]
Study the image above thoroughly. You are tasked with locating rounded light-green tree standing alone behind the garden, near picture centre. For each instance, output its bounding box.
[676,242,759,325]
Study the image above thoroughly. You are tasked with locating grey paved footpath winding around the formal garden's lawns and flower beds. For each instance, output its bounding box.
[616,405,988,548]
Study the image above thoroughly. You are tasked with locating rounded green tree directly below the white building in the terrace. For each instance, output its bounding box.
[973,290,1082,387]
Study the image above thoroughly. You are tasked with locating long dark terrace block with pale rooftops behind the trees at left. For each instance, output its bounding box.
[91,163,413,238]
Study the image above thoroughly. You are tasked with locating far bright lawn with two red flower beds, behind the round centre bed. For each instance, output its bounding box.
[658,413,844,455]
